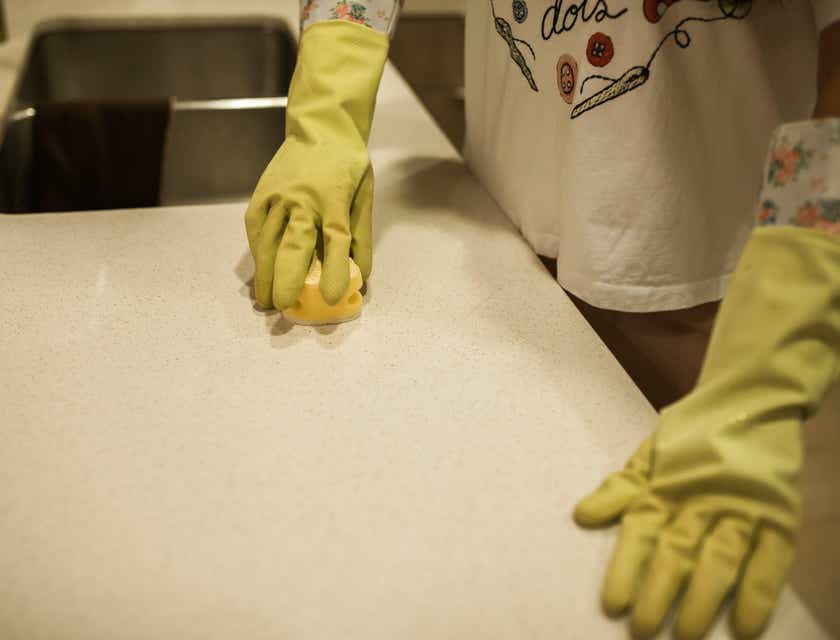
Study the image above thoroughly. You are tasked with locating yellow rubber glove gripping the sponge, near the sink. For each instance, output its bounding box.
[245,20,389,309]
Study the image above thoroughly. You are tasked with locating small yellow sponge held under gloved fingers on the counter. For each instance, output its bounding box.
[283,256,363,326]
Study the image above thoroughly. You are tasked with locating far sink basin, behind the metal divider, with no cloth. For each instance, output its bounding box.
[13,19,295,111]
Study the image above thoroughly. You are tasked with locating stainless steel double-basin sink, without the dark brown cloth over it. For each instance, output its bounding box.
[0,18,296,213]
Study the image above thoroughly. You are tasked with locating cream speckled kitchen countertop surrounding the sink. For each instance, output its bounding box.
[0,0,825,640]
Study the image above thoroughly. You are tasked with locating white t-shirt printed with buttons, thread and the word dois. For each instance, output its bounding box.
[466,0,840,312]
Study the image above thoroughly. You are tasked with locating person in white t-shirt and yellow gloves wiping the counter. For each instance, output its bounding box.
[245,0,840,638]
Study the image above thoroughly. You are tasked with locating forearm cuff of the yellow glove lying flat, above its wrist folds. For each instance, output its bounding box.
[698,227,840,415]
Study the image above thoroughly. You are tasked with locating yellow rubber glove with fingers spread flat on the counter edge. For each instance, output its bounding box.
[574,227,840,638]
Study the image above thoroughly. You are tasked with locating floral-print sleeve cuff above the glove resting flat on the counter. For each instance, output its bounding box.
[758,118,840,234]
